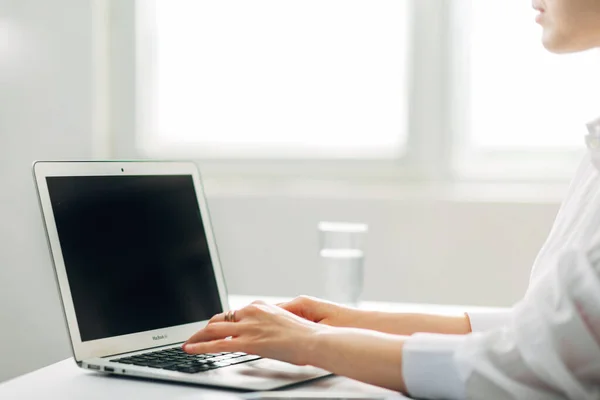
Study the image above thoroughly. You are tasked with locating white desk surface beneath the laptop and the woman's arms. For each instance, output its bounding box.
[0,296,502,400]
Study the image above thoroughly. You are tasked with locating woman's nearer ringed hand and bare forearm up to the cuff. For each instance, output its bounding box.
[183,300,406,391]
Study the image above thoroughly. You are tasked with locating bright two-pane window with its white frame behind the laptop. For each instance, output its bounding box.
[131,0,600,181]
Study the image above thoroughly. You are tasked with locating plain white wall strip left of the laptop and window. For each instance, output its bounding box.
[0,0,92,381]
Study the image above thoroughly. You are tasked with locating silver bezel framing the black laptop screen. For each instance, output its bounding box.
[33,161,229,361]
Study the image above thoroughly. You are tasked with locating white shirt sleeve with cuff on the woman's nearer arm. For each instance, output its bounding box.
[403,246,600,400]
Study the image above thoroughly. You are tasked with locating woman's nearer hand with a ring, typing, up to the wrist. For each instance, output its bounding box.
[183,301,327,365]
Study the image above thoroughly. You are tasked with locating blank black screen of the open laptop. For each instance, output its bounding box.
[46,175,222,342]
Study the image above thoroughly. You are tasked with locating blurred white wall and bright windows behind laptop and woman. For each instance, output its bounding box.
[0,0,600,381]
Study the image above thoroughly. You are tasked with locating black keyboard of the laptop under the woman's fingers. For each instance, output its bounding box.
[110,347,260,374]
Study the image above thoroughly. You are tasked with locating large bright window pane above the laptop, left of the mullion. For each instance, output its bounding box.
[142,0,408,159]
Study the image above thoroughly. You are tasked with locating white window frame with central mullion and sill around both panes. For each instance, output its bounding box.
[104,0,584,184]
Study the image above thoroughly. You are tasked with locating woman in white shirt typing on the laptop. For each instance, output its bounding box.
[184,0,600,399]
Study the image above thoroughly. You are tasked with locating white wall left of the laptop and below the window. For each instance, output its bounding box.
[0,0,557,388]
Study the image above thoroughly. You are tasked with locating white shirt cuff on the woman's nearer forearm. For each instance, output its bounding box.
[402,333,465,400]
